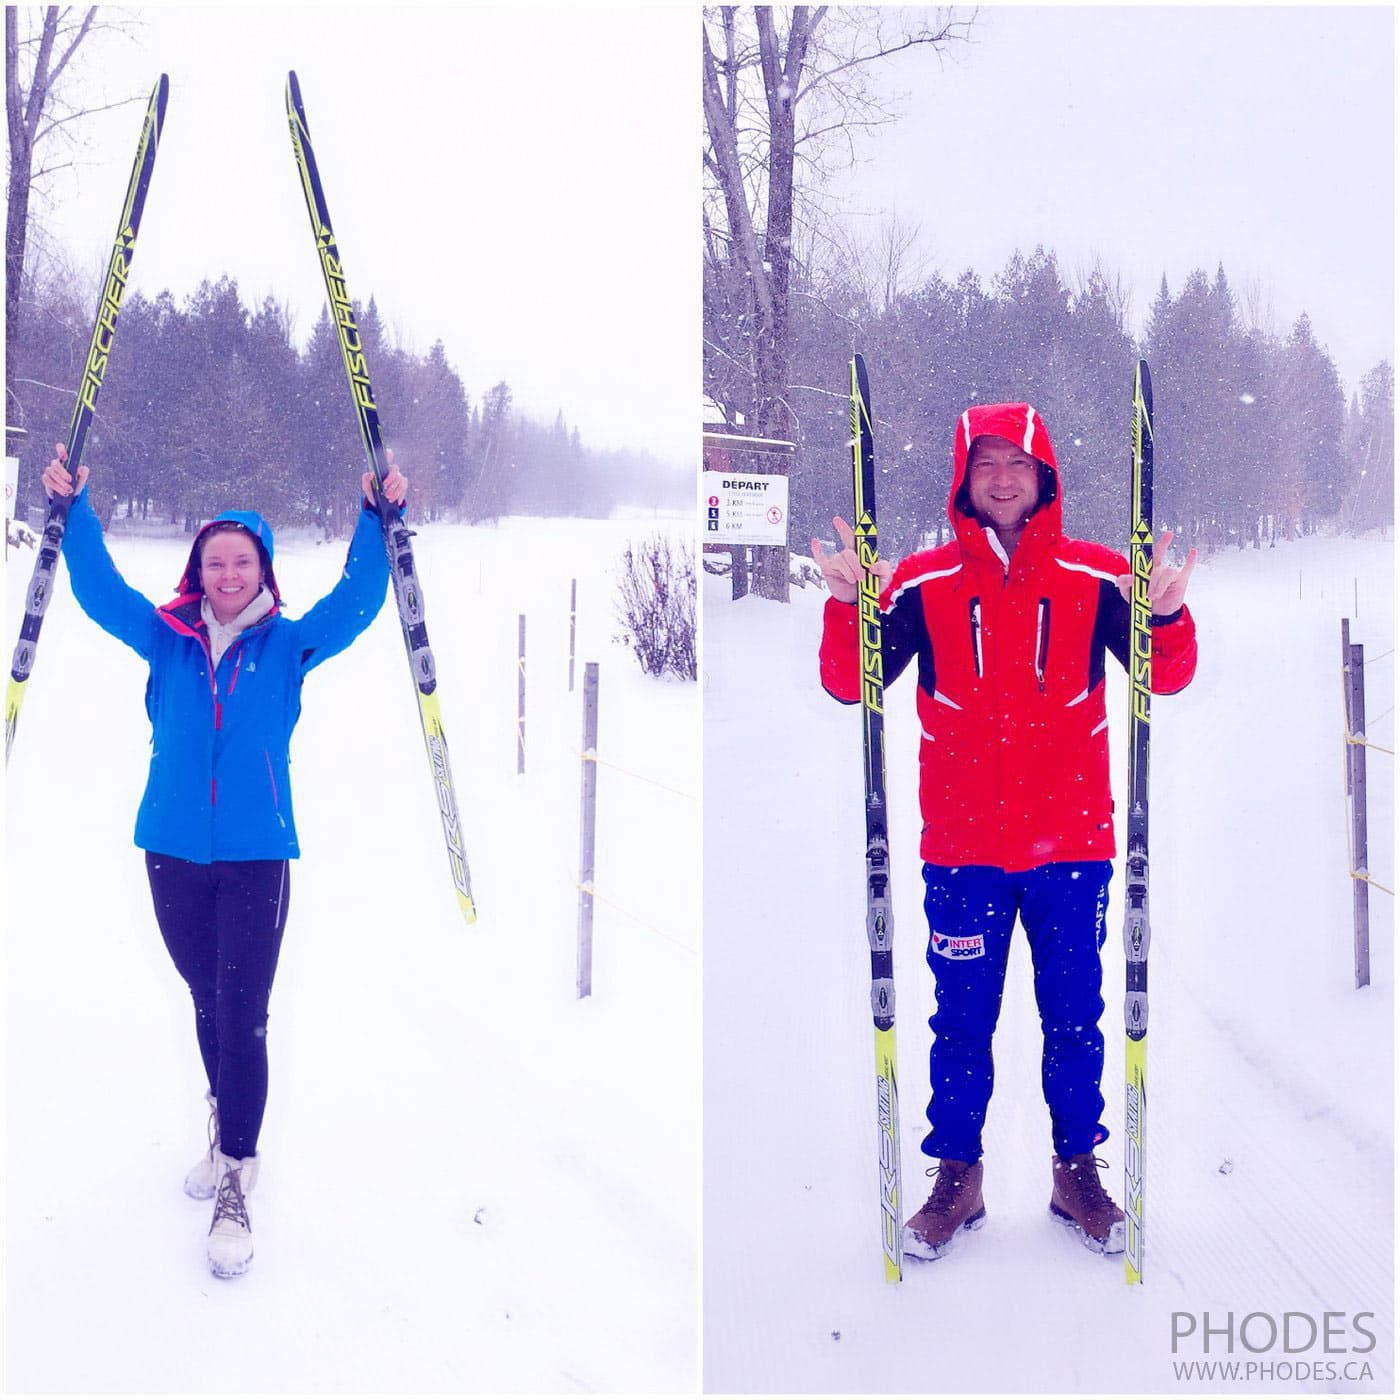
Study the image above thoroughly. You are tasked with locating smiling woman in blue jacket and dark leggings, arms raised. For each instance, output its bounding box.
[43,444,407,1278]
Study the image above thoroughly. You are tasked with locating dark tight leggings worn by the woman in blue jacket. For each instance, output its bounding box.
[146,851,288,1158]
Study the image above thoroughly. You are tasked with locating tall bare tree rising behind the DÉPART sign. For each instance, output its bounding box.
[701,6,972,601]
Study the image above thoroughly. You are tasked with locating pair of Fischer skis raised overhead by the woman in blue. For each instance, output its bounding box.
[4,73,476,923]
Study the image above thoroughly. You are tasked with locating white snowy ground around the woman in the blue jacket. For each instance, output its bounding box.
[4,518,700,1393]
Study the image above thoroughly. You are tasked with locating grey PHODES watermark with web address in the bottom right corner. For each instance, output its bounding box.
[1172,1309,1376,1382]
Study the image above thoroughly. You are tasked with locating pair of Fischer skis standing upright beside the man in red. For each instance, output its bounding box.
[851,356,1152,1284]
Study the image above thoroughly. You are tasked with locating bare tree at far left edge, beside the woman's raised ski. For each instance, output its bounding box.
[4,6,140,431]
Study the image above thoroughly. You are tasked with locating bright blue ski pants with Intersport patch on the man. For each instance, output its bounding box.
[923,861,1113,1162]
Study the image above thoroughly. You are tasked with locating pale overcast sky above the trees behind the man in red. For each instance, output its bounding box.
[843,4,1394,391]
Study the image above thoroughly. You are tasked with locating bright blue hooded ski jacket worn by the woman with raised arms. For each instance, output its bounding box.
[63,491,389,865]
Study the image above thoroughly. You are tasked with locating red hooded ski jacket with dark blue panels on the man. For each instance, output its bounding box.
[822,403,1196,871]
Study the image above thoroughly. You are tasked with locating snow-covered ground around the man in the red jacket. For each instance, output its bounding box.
[703,539,1396,1393]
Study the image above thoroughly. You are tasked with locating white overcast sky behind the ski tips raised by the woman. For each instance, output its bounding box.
[36,6,700,462]
